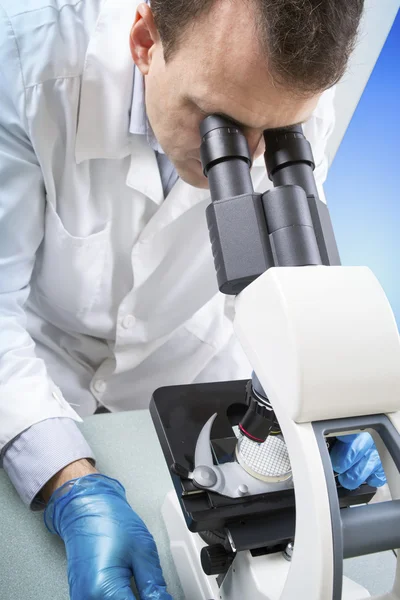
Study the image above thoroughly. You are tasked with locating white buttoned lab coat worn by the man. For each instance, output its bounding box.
[0,0,333,448]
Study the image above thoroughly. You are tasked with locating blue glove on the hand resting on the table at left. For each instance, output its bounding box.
[44,473,172,600]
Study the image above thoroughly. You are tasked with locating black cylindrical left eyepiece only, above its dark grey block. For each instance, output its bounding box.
[200,115,253,202]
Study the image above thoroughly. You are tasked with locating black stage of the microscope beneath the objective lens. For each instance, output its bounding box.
[150,380,376,551]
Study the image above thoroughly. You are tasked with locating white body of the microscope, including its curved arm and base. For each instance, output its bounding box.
[164,266,400,600]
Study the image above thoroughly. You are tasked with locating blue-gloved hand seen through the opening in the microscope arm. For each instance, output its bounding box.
[331,433,386,490]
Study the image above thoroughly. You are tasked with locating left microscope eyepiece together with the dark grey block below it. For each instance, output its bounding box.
[200,115,274,296]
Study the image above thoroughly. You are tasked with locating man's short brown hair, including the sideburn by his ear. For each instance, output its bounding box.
[151,0,364,93]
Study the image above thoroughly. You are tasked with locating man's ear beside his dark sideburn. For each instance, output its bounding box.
[129,3,160,75]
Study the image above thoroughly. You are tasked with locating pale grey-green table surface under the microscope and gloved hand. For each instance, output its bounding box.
[0,411,395,600]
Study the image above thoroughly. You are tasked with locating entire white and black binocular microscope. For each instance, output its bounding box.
[150,115,400,600]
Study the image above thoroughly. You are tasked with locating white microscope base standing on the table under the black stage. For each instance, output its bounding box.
[162,491,371,600]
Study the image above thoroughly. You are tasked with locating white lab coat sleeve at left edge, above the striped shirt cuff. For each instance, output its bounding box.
[0,10,95,506]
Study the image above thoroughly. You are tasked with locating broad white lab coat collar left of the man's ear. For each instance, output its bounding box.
[75,0,140,163]
